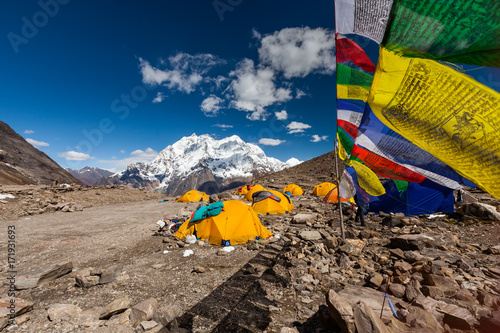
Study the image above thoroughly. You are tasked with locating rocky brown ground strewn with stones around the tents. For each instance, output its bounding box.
[0,178,500,332]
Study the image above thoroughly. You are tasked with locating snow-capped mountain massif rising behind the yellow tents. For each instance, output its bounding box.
[99,134,298,195]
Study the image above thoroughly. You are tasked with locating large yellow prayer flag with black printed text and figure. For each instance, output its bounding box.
[368,48,500,198]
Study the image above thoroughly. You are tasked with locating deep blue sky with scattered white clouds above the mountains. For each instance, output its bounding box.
[0,0,336,171]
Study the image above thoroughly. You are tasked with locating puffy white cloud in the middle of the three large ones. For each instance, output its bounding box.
[229,59,292,120]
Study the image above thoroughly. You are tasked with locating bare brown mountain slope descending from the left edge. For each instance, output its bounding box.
[0,121,82,185]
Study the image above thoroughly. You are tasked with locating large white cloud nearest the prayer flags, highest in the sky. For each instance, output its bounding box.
[254,27,335,78]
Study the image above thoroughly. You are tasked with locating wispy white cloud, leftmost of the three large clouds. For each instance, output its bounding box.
[139,53,225,94]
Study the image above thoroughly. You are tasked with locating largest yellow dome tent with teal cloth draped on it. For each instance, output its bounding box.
[174,200,273,245]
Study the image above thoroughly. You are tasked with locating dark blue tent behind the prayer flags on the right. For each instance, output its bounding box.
[368,179,455,215]
